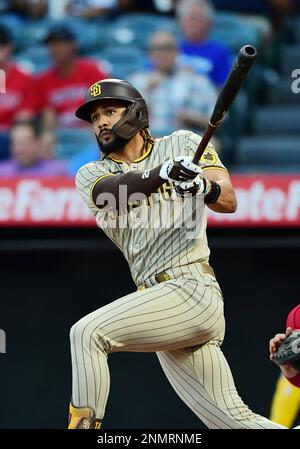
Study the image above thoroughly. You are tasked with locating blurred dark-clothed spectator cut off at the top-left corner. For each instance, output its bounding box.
[0,0,51,19]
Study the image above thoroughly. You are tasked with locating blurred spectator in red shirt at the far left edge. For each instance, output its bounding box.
[0,25,37,159]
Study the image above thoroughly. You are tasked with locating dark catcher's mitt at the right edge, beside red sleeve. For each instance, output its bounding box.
[274,330,300,373]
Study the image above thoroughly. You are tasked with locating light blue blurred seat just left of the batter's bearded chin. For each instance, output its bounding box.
[56,128,93,159]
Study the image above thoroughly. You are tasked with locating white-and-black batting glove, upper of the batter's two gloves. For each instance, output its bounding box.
[159,156,202,181]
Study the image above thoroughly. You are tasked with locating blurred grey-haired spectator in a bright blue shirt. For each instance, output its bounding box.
[177,0,231,87]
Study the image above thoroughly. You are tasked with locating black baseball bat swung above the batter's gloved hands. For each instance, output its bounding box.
[193,45,257,164]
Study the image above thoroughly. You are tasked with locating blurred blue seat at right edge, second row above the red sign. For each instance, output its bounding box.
[253,106,300,138]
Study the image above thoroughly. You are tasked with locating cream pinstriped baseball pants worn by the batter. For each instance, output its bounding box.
[70,264,282,429]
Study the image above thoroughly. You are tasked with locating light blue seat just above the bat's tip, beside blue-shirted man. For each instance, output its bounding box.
[210,12,261,52]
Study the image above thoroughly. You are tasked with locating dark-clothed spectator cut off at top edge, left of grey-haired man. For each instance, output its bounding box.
[118,0,177,14]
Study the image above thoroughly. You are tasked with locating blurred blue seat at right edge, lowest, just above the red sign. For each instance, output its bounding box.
[236,135,300,170]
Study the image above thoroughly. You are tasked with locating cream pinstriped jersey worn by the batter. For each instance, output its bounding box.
[76,131,226,286]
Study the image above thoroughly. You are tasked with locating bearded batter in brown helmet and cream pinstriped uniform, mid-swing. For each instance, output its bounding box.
[69,79,282,429]
